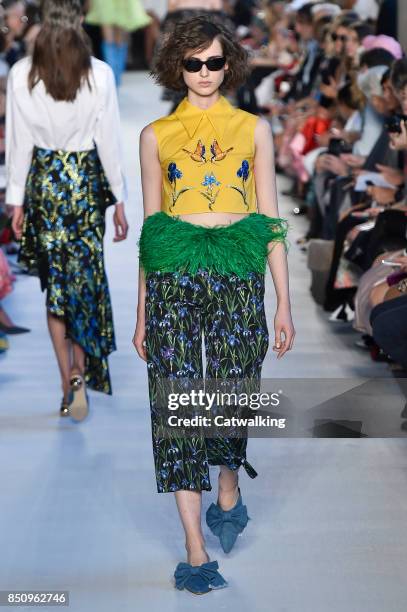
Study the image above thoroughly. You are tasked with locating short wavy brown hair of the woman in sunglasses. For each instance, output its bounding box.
[150,15,250,91]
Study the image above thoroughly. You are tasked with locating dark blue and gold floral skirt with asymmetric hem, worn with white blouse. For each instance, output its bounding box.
[18,147,116,394]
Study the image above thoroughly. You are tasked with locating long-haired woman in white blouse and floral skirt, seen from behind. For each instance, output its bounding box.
[6,0,128,420]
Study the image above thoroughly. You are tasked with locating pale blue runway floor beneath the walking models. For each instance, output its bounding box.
[0,73,407,612]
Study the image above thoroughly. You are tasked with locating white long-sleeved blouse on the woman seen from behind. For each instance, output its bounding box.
[6,57,127,206]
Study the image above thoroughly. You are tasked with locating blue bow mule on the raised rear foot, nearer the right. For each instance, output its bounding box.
[206,487,250,553]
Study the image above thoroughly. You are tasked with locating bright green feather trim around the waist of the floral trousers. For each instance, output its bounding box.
[137,211,290,278]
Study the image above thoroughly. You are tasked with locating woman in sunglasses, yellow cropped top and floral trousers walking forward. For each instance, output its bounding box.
[133,17,294,593]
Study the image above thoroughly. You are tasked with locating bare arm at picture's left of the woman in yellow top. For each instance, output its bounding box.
[133,125,162,361]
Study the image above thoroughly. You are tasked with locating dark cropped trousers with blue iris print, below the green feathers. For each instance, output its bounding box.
[146,268,269,493]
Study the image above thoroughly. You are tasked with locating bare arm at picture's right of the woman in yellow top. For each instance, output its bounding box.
[254,118,295,357]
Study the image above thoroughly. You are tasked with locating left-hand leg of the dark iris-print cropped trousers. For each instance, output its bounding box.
[146,272,212,493]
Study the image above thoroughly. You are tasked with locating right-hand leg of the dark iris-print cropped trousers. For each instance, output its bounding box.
[203,273,269,478]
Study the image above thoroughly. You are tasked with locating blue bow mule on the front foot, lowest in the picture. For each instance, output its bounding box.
[174,561,228,595]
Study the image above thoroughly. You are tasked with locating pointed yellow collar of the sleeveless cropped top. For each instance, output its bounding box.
[174,96,236,138]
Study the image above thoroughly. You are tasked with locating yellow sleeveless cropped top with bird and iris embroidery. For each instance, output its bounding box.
[151,96,258,216]
